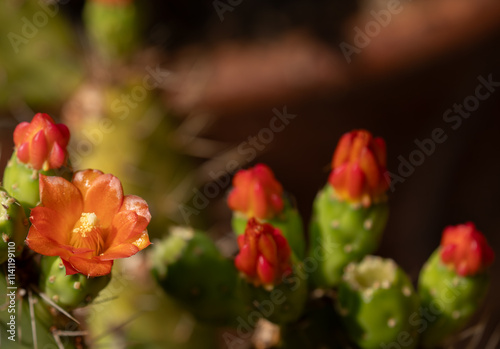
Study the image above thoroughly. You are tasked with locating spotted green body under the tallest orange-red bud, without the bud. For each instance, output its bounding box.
[309,184,389,288]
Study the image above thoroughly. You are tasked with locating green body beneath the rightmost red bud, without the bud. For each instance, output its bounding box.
[418,248,489,348]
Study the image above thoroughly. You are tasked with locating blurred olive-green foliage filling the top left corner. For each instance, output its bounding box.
[0,0,83,109]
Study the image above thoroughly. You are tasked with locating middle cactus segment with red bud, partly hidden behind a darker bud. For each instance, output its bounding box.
[228,164,306,260]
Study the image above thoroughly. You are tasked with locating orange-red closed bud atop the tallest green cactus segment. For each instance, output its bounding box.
[328,130,389,206]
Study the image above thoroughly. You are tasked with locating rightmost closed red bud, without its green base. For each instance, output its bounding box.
[441,222,495,276]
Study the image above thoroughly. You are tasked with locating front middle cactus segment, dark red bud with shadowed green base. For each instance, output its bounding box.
[234,218,308,324]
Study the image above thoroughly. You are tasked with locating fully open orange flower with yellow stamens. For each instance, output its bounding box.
[26,170,151,277]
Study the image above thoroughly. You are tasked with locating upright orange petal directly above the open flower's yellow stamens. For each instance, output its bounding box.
[83,174,123,229]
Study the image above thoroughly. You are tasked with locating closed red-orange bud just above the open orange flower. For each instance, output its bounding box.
[14,113,70,171]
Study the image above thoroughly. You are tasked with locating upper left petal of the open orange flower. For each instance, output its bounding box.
[40,174,83,224]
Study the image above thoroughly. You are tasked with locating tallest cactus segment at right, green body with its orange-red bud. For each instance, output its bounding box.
[309,130,389,288]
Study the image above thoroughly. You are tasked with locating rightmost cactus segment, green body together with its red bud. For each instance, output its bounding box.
[418,223,493,348]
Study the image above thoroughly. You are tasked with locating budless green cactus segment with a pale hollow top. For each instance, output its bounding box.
[337,256,419,349]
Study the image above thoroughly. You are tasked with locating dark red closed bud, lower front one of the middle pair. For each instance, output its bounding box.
[234,218,292,287]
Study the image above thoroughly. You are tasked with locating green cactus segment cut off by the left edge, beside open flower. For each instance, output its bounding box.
[0,187,28,264]
